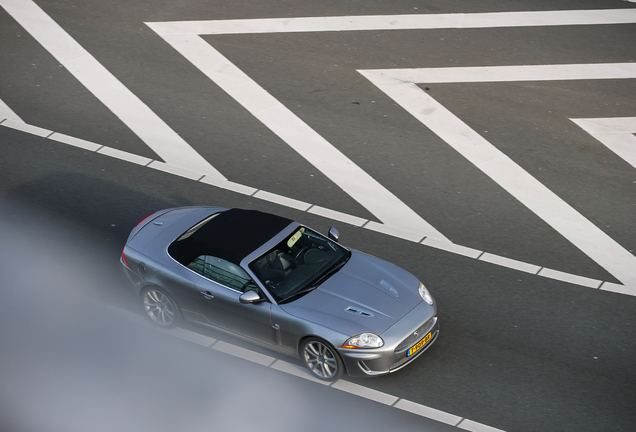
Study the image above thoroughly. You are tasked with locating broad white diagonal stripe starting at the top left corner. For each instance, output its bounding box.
[0,0,225,179]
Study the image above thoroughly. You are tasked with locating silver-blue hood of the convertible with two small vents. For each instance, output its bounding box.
[280,251,422,336]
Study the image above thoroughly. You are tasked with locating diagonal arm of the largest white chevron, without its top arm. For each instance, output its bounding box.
[147,28,446,240]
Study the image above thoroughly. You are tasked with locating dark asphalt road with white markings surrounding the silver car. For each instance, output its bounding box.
[0,0,636,432]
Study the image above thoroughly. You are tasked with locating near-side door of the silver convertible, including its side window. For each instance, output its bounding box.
[189,255,275,345]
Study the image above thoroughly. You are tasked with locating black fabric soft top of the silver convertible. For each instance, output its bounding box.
[168,209,293,266]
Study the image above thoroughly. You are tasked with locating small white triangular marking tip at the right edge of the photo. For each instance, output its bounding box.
[570,117,636,172]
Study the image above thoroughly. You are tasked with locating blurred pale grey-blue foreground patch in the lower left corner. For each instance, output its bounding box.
[0,200,442,432]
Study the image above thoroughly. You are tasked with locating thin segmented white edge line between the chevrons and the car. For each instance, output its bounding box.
[0,122,636,296]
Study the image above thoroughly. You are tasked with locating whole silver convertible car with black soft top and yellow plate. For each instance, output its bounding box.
[121,207,439,381]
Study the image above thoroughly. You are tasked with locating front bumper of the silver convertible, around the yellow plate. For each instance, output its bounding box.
[338,302,439,377]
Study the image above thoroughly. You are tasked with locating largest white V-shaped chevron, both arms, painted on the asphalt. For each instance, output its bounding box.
[146,9,636,240]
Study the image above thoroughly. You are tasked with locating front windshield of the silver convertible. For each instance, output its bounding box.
[249,227,351,303]
